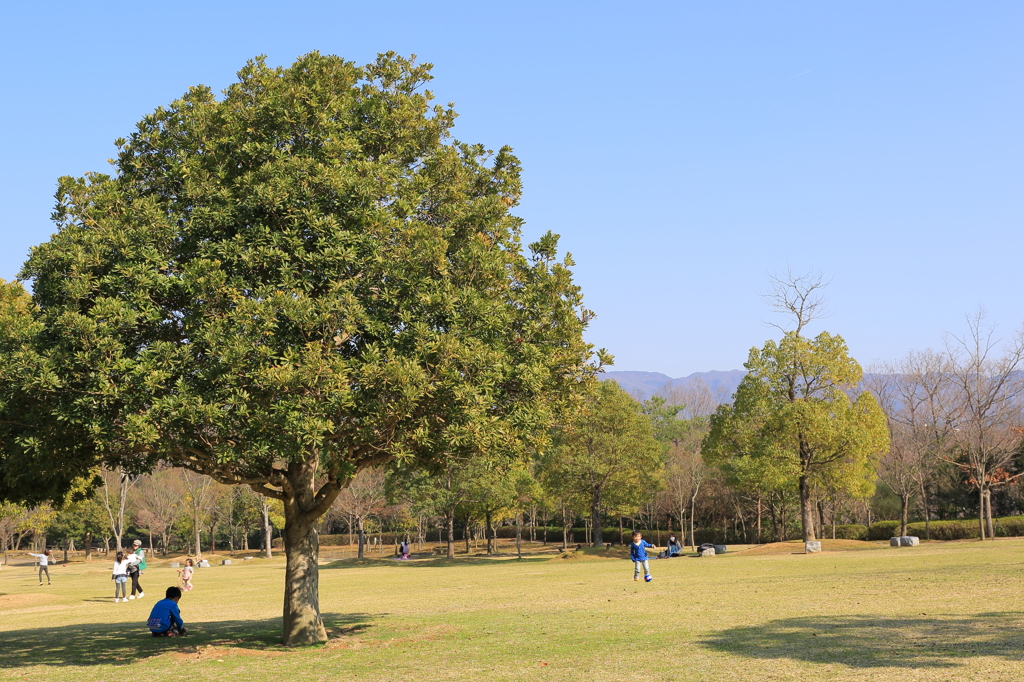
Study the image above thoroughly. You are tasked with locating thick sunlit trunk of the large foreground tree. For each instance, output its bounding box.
[284,516,327,646]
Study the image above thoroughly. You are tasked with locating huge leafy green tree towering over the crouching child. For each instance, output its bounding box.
[0,52,592,644]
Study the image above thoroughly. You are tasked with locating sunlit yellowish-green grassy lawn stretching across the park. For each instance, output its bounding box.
[0,539,1024,682]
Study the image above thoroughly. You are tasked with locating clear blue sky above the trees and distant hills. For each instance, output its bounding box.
[0,1,1024,376]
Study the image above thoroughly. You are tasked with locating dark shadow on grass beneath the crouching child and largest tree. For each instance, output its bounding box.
[0,613,373,670]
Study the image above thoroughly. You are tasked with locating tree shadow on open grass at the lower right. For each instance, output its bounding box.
[700,612,1024,668]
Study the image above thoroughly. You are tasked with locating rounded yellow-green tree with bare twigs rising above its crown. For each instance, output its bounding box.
[702,332,889,541]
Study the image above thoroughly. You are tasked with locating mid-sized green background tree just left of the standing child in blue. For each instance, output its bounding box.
[541,381,665,547]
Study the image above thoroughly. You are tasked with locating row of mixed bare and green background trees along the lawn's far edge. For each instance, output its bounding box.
[6,301,1024,556]
